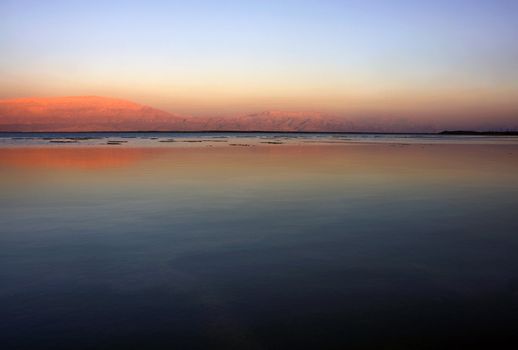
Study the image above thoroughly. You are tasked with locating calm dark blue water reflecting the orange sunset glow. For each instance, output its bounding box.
[0,134,518,349]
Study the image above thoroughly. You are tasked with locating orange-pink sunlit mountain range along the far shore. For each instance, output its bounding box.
[0,96,428,132]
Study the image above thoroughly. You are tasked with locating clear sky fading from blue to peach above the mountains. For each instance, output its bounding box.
[0,0,518,127]
